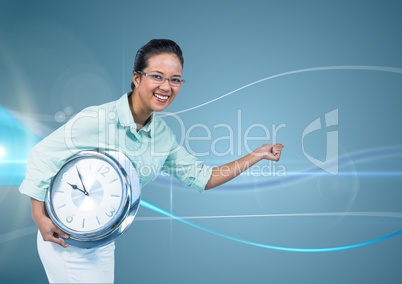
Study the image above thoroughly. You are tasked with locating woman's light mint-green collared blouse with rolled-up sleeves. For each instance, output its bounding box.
[19,93,212,201]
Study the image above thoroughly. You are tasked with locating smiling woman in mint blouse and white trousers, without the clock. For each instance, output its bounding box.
[20,39,284,283]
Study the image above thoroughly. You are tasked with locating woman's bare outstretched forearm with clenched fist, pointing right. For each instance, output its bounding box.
[205,143,284,189]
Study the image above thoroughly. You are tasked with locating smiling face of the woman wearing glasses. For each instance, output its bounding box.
[133,53,183,112]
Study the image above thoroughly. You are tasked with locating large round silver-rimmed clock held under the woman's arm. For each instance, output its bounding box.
[45,151,141,248]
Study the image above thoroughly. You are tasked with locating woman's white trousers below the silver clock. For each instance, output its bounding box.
[37,231,115,283]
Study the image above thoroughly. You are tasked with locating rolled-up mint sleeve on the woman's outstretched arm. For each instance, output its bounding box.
[164,142,212,192]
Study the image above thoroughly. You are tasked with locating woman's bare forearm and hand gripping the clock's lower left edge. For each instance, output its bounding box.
[31,198,69,248]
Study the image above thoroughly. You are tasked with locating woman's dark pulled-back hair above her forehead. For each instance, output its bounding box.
[131,39,184,90]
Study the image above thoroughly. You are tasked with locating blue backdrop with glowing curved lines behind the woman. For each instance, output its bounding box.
[0,0,402,283]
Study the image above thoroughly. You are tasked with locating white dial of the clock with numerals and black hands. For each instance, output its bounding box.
[50,156,127,234]
